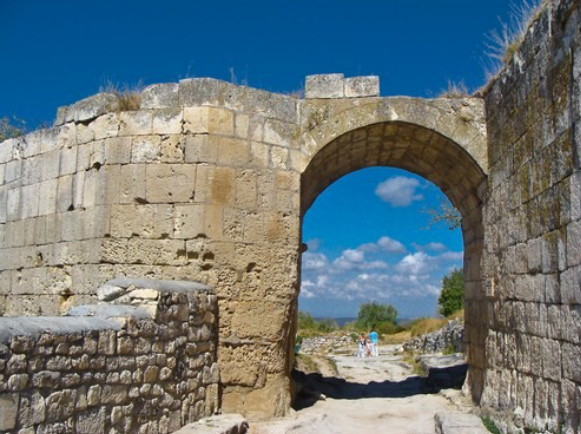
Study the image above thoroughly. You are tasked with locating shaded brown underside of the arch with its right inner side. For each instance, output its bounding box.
[301,121,488,402]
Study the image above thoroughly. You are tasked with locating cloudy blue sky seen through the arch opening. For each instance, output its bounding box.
[299,167,462,318]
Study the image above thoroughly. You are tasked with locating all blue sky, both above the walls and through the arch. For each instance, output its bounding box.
[0,0,510,316]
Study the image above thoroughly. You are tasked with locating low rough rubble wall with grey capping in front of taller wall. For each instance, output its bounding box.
[0,278,219,434]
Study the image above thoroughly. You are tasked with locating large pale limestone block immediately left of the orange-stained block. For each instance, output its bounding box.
[146,164,196,203]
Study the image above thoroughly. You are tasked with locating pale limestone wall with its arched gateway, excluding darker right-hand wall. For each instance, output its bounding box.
[1,74,487,417]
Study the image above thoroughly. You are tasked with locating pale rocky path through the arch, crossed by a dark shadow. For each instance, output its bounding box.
[250,347,474,434]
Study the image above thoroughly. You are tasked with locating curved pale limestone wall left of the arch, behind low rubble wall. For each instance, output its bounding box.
[0,79,301,415]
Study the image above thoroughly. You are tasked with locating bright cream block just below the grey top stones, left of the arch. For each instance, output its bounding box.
[184,107,234,135]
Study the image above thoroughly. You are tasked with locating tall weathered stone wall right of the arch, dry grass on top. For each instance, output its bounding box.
[481,0,581,433]
